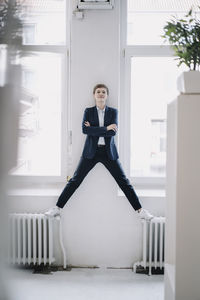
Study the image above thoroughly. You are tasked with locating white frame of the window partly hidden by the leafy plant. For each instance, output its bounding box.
[119,0,177,190]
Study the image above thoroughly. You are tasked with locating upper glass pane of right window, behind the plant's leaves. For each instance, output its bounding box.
[127,0,199,45]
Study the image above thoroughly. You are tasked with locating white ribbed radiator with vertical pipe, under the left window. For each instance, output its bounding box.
[8,213,66,268]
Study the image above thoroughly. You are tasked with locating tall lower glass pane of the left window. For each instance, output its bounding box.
[8,52,62,175]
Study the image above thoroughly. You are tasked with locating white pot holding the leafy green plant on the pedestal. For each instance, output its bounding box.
[177,71,200,94]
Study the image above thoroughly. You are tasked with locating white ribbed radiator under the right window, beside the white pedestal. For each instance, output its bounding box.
[133,217,165,275]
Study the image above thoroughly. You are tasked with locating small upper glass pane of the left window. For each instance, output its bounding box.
[22,0,66,45]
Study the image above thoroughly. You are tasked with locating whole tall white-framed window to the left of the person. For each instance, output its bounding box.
[10,0,69,182]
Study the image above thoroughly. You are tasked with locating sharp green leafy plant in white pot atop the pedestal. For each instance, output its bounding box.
[161,6,200,94]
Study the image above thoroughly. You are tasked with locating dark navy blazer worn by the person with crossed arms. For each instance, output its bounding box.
[82,105,119,160]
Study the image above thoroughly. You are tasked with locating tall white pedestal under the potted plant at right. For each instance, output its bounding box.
[165,93,200,300]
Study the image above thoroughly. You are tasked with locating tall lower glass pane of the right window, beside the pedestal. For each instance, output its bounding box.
[131,57,186,177]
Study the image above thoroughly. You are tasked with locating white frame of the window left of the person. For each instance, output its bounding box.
[8,1,72,187]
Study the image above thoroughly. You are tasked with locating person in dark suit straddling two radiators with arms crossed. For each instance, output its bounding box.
[45,84,153,220]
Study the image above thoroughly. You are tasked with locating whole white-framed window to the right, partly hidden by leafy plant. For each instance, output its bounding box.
[120,0,199,188]
